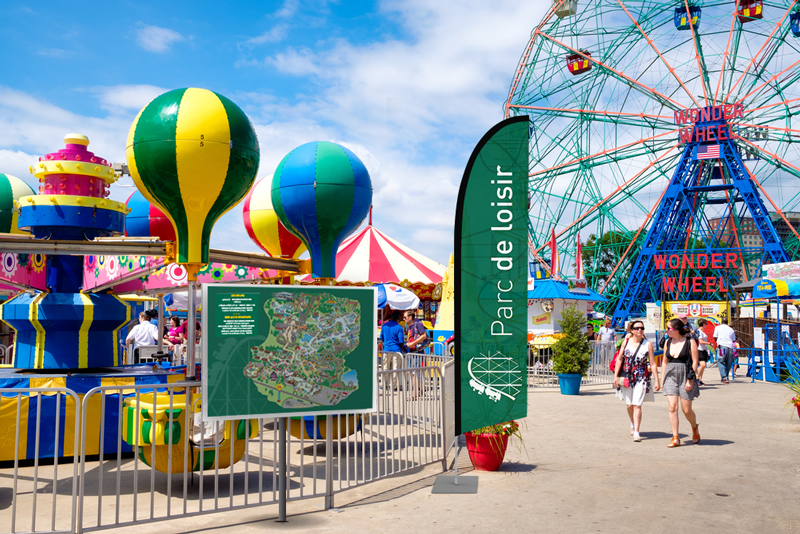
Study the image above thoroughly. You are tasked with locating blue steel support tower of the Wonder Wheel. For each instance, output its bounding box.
[613,108,790,326]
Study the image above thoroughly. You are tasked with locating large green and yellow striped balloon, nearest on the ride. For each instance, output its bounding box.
[127,88,259,273]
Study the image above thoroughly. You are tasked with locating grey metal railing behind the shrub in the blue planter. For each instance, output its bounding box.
[528,341,616,388]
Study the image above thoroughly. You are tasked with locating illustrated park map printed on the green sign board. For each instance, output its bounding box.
[244,292,361,409]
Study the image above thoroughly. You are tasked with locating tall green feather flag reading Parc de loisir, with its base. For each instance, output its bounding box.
[434,116,530,493]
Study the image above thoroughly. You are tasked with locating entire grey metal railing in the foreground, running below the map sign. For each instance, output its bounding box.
[0,366,445,532]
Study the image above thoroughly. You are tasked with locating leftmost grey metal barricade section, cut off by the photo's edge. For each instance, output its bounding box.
[0,387,81,533]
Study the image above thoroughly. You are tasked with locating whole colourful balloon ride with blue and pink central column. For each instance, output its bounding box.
[0,89,372,472]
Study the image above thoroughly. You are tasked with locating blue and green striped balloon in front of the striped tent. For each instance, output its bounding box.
[272,141,372,278]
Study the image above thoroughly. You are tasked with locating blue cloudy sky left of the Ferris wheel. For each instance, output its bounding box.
[0,0,549,263]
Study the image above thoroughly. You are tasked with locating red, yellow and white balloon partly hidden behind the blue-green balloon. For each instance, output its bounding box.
[242,176,306,259]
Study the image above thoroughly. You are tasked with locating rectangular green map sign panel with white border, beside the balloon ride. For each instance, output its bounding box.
[202,284,377,420]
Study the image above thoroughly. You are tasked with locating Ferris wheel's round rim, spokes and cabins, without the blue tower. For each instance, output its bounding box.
[505,0,800,307]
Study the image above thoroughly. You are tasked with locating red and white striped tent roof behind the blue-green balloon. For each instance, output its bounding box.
[297,225,447,299]
